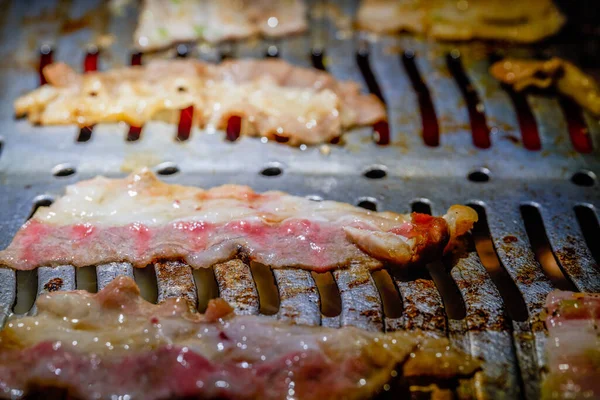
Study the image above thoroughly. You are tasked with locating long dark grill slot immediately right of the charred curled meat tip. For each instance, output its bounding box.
[469,204,528,322]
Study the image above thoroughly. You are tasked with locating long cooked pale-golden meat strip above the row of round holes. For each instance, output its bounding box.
[15,59,386,146]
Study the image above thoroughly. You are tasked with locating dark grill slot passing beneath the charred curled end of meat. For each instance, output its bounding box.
[412,201,467,320]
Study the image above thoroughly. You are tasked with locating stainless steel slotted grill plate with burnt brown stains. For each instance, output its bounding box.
[0,0,600,399]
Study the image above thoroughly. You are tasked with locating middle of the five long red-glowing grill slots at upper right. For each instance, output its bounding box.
[446,50,491,149]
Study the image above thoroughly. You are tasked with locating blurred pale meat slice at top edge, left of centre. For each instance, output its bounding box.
[134,0,307,50]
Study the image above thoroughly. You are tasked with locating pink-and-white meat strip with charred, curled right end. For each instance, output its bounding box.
[0,170,477,271]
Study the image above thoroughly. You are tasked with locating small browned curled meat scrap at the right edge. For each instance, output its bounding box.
[490,58,600,116]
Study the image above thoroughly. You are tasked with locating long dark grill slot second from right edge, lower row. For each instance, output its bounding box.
[521,204,577,291]
